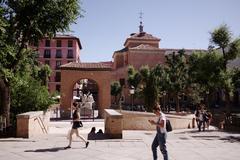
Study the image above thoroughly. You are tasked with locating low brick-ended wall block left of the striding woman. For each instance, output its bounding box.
[17,111,50,138]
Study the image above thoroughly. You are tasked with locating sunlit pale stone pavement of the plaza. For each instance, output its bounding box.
[0,120,240,160]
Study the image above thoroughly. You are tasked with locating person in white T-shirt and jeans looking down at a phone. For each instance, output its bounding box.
[148,104,168,160]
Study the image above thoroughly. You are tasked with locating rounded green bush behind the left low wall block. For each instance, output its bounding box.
[11,76,53,115]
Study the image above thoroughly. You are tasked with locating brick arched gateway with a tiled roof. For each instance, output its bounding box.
[60,62,112,118]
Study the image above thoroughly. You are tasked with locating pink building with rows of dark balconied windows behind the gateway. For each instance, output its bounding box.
[35,35,82,93]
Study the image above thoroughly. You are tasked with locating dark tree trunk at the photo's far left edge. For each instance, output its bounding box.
[0,79,10,127]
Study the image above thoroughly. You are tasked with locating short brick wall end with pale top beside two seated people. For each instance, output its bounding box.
[105,109,123,138]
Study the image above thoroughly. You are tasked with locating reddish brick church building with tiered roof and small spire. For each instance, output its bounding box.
[112,23,203,104]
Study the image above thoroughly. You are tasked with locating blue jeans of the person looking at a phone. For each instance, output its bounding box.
[152,132,168,160]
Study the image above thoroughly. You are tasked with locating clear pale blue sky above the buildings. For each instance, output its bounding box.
[70,0,240,62]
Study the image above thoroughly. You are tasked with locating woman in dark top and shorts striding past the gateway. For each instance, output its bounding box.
[65,102,89,149]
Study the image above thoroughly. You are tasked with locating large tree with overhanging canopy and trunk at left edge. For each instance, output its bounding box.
[0,0,81,126]
